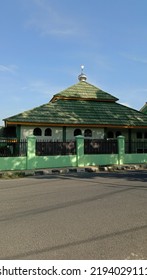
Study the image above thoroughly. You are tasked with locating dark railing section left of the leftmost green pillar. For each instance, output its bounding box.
[0,139,27,157]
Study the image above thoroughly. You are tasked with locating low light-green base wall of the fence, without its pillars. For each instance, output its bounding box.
[0,154,147,171]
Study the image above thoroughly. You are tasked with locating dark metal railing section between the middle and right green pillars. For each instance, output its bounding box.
[84,139,118,154]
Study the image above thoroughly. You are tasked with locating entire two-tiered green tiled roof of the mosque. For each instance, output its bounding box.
[5,82,147,127]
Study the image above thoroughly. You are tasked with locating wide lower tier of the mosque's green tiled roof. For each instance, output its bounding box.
[3,100,147,126]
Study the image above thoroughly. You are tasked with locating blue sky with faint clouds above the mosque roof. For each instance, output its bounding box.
[0,0,147,125]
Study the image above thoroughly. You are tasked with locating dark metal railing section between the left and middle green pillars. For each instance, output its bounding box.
[36,140,76,156]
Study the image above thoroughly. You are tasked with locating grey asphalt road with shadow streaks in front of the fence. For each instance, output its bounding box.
[0,171,147,260]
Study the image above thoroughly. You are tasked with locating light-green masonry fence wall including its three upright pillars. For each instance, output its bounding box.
[0,135,147,171]
